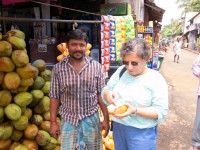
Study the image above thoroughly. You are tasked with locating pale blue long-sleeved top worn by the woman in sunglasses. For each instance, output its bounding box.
[101,66,168,129]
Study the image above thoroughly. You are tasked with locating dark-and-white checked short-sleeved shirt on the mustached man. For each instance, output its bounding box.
[49,56,105,126]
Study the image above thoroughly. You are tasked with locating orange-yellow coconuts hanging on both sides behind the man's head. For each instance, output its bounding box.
[57,43,92,61]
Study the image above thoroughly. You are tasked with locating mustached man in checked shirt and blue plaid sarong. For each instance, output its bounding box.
[49,29,109,150]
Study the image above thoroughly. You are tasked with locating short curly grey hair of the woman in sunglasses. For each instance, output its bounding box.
[120,38,151,61]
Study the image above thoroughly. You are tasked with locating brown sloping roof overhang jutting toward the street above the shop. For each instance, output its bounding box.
[144,3,165,22]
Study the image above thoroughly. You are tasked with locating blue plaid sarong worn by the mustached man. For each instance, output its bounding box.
[61,111,103,150]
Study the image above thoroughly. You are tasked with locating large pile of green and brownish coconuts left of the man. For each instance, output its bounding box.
[0,30,60,150]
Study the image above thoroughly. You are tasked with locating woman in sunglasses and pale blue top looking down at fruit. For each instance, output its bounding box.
[101,38,168,150]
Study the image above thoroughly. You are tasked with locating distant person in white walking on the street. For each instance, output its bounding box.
[173,37,182,63]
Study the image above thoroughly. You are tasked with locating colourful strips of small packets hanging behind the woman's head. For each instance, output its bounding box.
[101,15,135,72]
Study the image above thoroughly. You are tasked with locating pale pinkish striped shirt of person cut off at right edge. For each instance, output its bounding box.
[192,55,200,96]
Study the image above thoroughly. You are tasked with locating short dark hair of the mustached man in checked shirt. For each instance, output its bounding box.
[66,29,88,43]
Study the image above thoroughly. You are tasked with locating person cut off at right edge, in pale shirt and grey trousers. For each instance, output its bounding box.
[189,49,200,150]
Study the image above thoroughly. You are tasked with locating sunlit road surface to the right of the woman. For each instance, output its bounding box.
[157,48,198,150]
